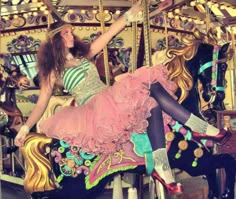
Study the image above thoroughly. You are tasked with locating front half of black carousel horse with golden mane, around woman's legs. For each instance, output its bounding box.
[136,26,236,199]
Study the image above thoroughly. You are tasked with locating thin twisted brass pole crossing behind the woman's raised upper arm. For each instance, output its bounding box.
[99,0,111,86]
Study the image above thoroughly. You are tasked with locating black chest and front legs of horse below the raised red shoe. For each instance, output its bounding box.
[168,133,236,199]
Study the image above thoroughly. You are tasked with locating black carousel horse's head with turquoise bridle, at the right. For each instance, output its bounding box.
[194,43,229,110]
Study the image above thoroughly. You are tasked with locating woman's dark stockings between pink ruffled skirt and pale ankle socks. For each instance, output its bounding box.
[147,82,191,151]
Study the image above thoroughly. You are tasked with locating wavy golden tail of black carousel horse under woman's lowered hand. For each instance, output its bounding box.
[22,133,57,193]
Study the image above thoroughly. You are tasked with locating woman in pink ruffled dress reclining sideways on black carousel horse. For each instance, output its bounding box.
[15,3,229,193]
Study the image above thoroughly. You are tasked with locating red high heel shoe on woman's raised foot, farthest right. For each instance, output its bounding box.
[192,129,232,145]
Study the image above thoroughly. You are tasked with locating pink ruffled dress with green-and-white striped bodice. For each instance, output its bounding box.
[40,60,177,155]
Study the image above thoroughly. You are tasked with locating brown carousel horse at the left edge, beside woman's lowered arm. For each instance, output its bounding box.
[0,65,29,153]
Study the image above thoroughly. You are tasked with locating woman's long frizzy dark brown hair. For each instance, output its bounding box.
[37,21,90,85]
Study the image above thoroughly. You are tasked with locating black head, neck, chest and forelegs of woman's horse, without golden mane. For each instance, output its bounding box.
[165,40,236,199]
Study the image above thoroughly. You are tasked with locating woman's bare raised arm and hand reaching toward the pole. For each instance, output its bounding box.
[88,2,142,59]
